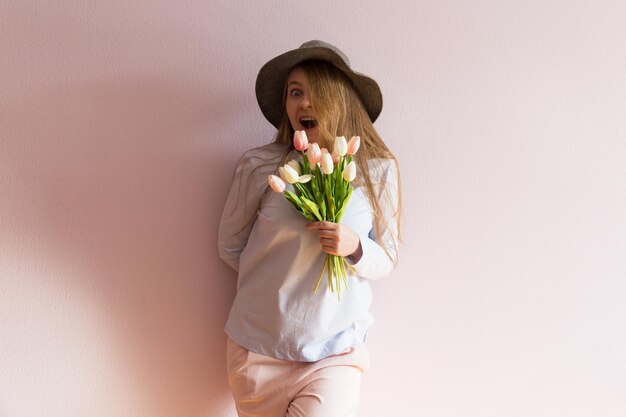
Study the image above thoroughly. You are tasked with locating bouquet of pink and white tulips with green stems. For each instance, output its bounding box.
[268,130,361,297]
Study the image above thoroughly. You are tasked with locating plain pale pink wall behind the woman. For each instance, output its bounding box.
[0,0,626,417]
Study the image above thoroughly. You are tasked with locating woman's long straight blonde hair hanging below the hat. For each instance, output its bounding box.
[261,61,402,263]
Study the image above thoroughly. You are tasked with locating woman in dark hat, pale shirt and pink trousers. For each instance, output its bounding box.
[218,41,401,417]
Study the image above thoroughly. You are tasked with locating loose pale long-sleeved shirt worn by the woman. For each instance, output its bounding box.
[218,144,397,362]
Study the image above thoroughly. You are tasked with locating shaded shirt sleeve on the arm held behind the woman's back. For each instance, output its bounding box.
[218,153,263,271]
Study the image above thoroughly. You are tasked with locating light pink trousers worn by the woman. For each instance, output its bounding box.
[226,339,369,417]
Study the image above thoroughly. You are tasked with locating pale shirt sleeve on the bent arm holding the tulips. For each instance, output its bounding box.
[353,160,400,280]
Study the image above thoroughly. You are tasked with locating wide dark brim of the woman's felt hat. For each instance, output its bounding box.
[255,47,383,128]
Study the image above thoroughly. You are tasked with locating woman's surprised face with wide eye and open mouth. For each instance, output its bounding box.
[285,68,318,142]
